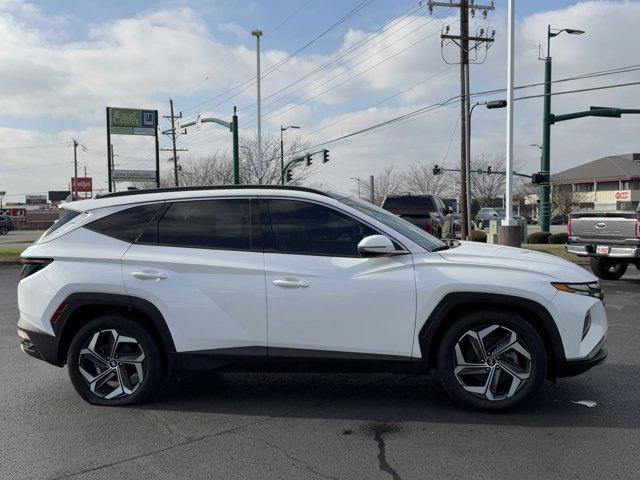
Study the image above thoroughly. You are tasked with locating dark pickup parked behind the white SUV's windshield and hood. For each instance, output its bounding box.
[382,195,449,238]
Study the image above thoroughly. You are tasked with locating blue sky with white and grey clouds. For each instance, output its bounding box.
[0,0,640,201]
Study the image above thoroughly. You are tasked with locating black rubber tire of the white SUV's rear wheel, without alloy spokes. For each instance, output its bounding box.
[67,313,167,406]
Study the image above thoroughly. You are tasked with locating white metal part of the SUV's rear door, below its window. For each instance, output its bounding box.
[122,245,267,351]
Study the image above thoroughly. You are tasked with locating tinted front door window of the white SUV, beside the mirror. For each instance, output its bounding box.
[265,200,377,257]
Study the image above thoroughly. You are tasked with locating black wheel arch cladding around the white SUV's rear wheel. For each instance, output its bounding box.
[52,292,176,366]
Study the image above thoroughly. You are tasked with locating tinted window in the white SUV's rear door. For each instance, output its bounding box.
[158,199,251,250]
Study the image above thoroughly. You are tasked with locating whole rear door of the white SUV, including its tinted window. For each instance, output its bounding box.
[122,198,267,354]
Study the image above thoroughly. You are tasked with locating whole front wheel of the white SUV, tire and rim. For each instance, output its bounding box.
[437,310,547,412]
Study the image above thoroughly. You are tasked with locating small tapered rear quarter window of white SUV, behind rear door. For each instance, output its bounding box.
[87,203,162,242]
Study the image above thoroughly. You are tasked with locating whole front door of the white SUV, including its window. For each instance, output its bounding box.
[260,199,416,357]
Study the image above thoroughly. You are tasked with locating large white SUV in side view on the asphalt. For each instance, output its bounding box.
[18,186,607,411]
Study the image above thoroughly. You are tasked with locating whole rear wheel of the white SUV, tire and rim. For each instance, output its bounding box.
[67,314,166,406]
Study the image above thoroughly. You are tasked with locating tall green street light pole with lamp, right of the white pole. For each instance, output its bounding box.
[540,25,584,232]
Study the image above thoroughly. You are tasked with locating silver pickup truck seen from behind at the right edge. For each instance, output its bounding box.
[565,206,640,280]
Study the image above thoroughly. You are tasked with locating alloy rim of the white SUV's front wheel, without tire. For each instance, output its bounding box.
[454,325,531,401]
